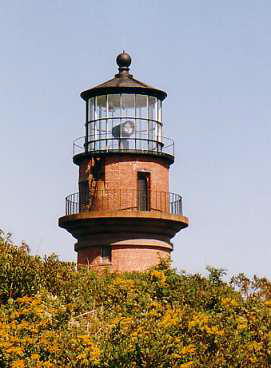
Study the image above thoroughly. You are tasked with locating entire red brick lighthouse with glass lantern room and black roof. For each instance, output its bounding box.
[59,52,188,271]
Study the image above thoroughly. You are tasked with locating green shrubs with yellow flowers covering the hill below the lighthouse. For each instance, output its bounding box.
[0,240,271,368]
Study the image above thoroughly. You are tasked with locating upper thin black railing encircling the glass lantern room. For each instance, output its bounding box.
[73,136,174,156]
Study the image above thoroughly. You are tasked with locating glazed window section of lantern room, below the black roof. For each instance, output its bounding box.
[86,93,163,152]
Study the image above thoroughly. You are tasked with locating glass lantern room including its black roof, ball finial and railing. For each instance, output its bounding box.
[74,52,173,158]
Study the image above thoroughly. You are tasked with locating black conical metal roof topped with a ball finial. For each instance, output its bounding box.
[80,51,167,101]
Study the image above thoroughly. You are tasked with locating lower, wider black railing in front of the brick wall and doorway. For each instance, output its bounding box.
[66,189,182,215]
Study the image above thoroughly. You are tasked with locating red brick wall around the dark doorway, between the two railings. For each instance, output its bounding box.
[79,154,169,211]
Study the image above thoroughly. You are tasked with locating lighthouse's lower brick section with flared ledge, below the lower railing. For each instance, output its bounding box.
[59,211,188,272]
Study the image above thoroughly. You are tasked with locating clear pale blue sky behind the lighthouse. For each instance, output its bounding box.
[0,0,271,277]
